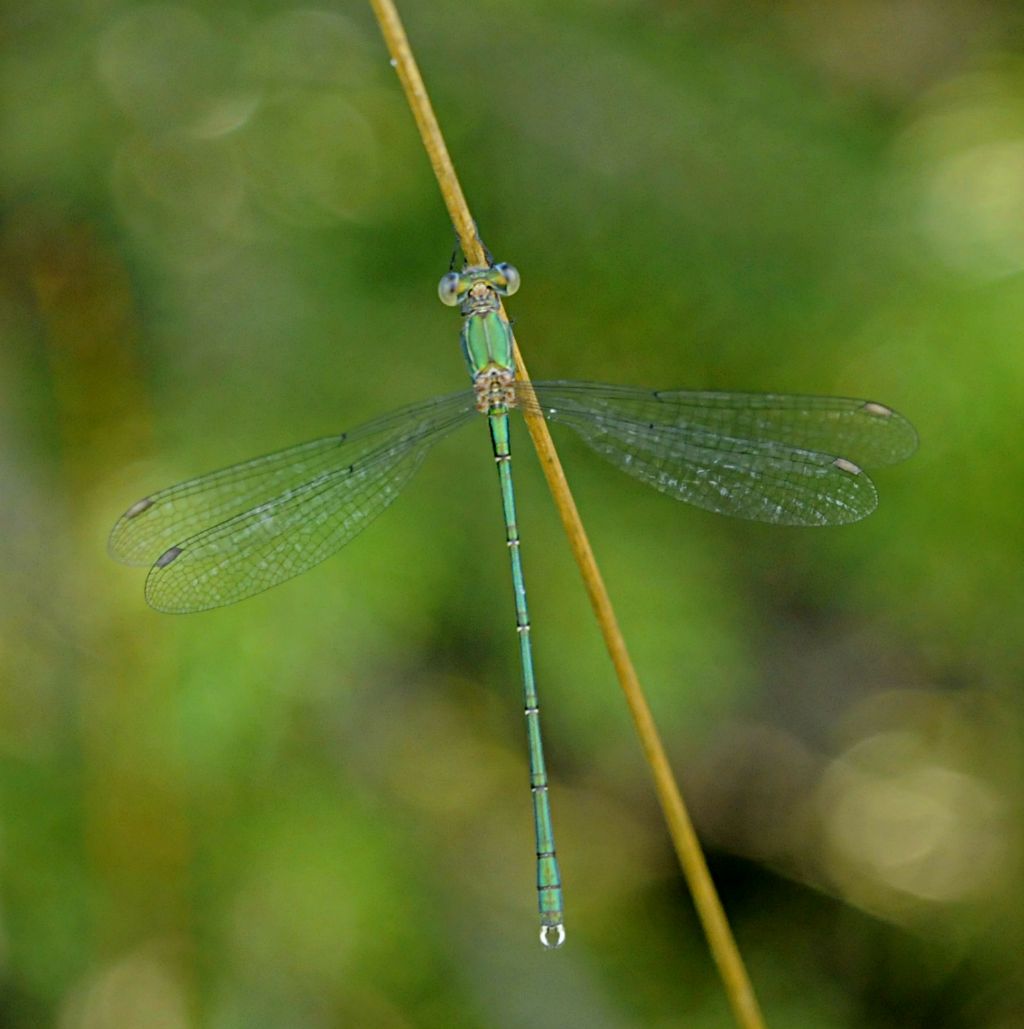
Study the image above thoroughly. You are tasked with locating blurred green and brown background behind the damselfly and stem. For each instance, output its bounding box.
[0,0,1024,1029]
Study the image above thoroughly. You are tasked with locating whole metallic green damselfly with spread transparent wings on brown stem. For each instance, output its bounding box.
[110,263,917,947]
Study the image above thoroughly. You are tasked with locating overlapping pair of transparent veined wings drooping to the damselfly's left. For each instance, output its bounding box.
[110,390,474,612]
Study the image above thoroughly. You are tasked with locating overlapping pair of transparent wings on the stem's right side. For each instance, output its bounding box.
[520,382,917,526]
